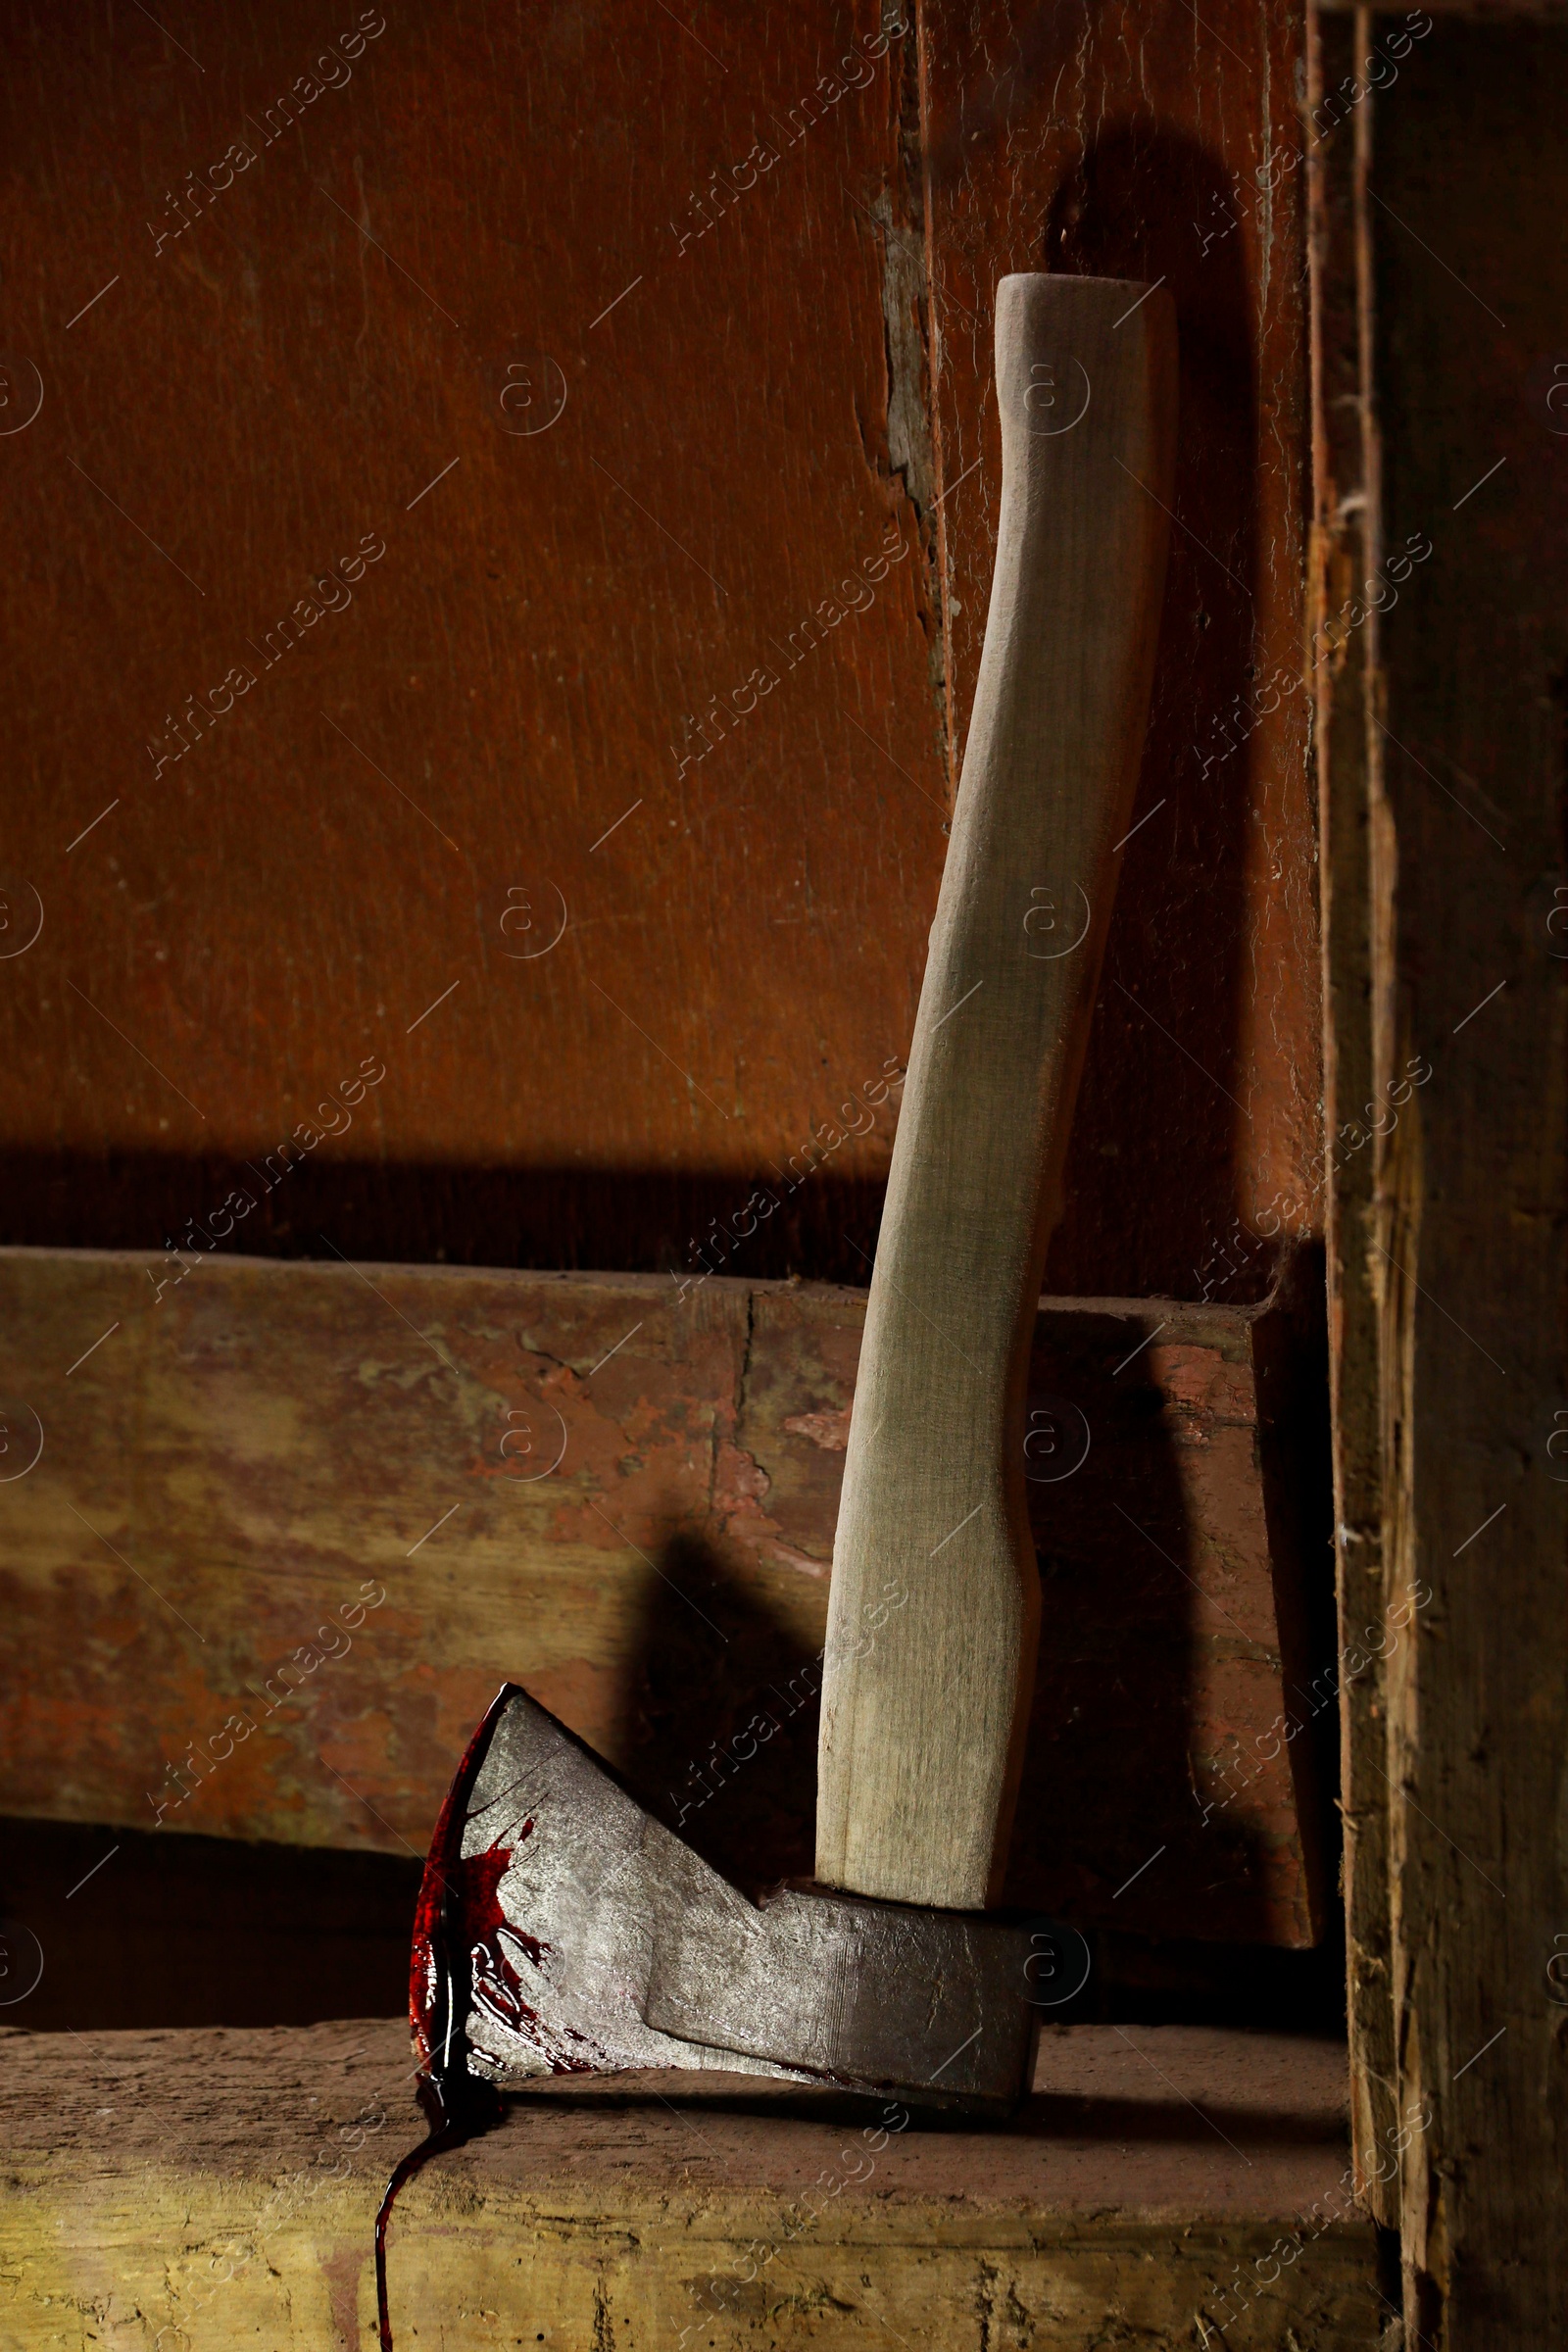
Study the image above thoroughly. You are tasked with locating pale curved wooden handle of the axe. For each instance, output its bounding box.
[815,275,1175,1910]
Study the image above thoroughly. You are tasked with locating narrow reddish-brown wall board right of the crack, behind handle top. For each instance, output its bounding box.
[921,0,1321,1296]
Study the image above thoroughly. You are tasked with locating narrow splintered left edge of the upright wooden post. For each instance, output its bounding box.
[1307,0,1398,2228]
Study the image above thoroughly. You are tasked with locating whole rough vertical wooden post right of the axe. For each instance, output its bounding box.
[1314,14,1568,2352]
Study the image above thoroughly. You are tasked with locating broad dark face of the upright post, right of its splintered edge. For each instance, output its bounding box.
[1368,22,1568,2352]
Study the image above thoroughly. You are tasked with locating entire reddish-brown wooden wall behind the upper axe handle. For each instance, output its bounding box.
[0,0,1316,1296]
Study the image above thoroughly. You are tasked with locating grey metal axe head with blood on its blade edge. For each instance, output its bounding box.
[412,1684,1086,2112]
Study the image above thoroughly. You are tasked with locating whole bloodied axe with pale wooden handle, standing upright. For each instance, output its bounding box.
[412,275,1175,2131]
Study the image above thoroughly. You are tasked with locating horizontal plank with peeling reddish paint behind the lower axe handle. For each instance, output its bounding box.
[0,1251,1333,1942]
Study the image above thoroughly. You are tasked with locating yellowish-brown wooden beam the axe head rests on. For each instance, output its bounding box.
[0,2021,1385,2352]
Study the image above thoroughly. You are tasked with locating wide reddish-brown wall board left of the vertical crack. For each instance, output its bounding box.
[0,0,948,1272]
